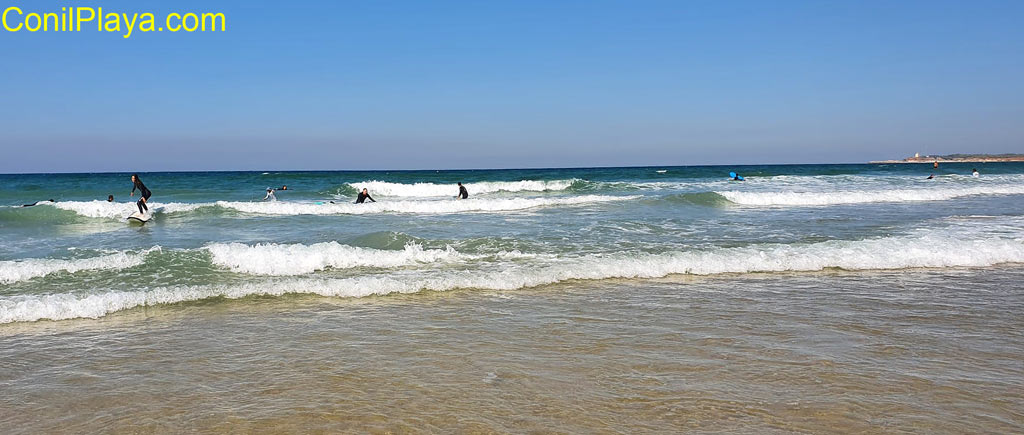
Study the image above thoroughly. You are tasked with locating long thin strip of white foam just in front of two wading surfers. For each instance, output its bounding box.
[217,194,640,215]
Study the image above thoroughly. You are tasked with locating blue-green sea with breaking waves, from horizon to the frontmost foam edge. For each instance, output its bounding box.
[0,160,1024,323]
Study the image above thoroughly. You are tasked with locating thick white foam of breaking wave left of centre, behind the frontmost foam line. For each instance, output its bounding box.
[206,242,474,275]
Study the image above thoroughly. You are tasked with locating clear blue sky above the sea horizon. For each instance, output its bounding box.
[0,0,1024,173]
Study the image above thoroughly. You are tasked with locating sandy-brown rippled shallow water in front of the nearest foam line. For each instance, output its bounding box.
[0,267,1024,433]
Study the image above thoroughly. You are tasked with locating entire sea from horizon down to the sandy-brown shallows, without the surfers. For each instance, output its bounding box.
[0,163,1024,433]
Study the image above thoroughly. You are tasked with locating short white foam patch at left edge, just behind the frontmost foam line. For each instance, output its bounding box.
[0,252,145,284]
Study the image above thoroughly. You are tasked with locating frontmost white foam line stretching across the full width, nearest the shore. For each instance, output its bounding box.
[0,228,1024,323]
